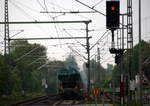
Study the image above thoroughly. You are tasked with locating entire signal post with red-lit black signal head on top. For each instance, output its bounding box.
[106,0,124,106]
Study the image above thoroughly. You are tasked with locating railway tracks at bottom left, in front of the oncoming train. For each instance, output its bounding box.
[9,95,83,106]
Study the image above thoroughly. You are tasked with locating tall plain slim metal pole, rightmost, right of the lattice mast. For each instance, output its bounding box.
[139,0,143,106]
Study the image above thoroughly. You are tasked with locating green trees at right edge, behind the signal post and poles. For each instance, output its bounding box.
[113,41,150,86]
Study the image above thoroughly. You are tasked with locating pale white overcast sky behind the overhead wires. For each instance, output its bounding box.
[0,0,150,67]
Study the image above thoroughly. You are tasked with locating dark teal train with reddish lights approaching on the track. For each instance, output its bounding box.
[58,67,84,99]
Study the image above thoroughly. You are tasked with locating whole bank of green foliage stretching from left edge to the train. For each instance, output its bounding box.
[0,41,68,105]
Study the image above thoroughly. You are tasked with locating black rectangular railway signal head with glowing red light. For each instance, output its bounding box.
[106,1,120,30]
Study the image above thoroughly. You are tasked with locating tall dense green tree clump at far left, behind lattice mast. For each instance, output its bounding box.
[0,41,46,96]
